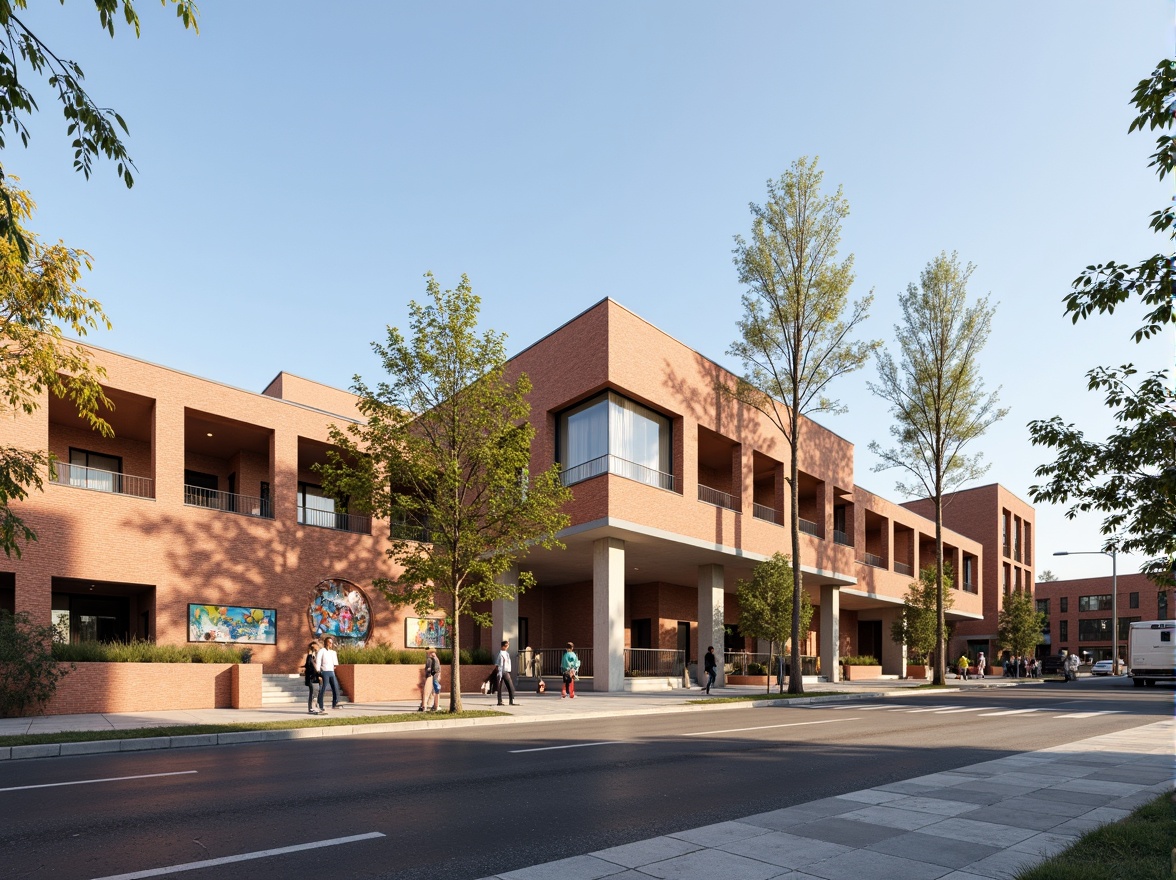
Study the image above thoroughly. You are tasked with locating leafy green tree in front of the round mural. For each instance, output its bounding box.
[320,273,572,712]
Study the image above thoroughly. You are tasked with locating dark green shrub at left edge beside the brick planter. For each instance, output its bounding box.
[0,611,73,718]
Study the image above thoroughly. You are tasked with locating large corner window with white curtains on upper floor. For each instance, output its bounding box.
[560,392,674,488]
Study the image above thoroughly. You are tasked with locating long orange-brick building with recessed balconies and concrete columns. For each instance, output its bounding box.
[0,299,1033,691]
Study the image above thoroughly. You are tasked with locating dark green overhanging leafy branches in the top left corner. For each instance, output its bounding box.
[0,0,199,260]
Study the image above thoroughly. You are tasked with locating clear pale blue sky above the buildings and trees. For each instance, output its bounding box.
[11,0,1174,576]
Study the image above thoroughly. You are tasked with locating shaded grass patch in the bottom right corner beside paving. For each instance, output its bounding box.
[1016,793,1176,880]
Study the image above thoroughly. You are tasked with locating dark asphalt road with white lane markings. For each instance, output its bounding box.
[0,679,1172,880]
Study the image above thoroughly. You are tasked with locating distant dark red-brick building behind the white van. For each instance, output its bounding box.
[1034,574,1171,661]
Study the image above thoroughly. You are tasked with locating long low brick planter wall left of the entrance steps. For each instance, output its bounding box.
[41,664,261,715]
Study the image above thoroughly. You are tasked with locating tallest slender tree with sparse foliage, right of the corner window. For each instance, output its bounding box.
[719,156,877,694]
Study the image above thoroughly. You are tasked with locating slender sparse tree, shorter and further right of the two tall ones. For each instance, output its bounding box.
[868,252,1008,685]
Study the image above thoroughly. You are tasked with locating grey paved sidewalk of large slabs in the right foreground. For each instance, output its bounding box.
[472,720,1176,880]
